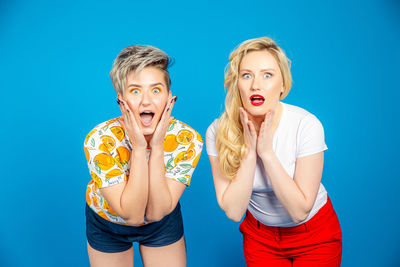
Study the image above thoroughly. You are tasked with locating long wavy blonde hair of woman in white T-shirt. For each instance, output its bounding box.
[216,37,292,179]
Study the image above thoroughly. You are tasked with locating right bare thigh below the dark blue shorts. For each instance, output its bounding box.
[139,236,186,267]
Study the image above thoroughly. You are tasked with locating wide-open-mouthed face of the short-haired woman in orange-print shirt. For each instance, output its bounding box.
[122,67,169,136]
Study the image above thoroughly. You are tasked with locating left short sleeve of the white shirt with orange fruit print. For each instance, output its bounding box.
[83,131,126,188]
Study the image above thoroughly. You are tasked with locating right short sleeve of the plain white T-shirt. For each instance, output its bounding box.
[296,114,328,158]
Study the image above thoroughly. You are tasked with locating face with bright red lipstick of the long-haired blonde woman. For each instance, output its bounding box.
[238,50,283,117]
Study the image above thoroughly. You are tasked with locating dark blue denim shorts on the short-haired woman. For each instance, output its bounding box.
[85,202,183,253]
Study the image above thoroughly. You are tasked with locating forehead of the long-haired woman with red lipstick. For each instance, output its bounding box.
[239,50,279,70]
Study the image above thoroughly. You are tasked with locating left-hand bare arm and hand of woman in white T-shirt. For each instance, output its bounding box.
[209,108,257,222]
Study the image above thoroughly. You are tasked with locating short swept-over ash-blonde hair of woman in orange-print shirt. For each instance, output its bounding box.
[110,45,172,94]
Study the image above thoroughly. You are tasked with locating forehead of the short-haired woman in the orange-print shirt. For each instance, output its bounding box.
[126,67,167,86]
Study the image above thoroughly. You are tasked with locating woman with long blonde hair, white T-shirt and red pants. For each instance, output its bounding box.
[206,37,342,266]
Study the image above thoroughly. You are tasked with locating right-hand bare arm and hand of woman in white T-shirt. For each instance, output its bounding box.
[257,113,324,223]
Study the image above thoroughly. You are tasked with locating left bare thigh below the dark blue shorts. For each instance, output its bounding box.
[87,242,133,267]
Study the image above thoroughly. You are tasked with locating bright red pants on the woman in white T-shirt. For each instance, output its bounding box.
[239,198,342,267]
